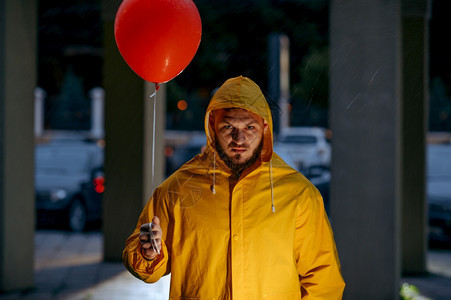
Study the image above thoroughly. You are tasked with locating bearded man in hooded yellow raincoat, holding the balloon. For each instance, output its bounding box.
[123,76,344,300]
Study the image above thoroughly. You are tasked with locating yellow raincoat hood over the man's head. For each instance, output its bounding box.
[205,76,273,162]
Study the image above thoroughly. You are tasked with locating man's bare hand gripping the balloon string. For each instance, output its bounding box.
[139,216,163,260]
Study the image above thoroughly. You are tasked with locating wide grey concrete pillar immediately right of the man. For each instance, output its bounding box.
[330,0,402,300]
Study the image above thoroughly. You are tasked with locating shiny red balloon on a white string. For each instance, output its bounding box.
[114,0,202,83]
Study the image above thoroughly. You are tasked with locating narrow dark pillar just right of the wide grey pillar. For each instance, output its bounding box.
[401,0,430,275]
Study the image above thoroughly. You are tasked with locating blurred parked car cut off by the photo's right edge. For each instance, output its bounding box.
[426,144,451,242]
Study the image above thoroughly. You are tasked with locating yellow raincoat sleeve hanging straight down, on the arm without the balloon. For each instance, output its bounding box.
[295,185,345,300]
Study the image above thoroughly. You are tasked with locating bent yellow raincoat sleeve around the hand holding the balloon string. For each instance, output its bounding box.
[122,193,170,283]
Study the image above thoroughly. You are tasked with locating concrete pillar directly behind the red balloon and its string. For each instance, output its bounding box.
[102,0,165,260]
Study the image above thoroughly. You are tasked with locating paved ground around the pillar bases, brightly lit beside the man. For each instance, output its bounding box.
[0,230,451,300]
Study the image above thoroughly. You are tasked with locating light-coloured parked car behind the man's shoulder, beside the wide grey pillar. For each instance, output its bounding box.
[275,127,331,177]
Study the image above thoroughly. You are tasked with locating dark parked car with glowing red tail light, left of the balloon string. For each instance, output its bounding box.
[35,141,105,232]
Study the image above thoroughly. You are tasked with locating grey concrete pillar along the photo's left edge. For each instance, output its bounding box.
[0,0,37,291]
